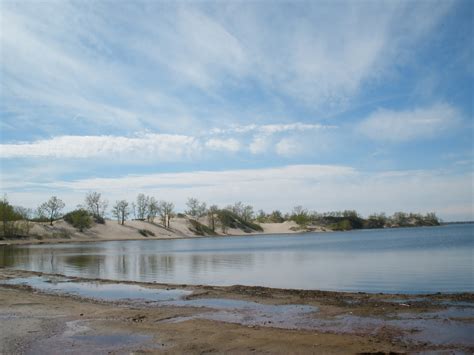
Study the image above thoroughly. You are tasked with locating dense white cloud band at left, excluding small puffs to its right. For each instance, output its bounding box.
[0,133,201,161]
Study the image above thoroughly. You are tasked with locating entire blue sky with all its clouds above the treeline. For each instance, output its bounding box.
[0,0,474,221]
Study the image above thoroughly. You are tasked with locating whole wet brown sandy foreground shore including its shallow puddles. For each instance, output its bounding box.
[0,269,474,354]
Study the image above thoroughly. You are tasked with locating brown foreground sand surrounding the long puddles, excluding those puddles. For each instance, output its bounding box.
[0,269,474,354]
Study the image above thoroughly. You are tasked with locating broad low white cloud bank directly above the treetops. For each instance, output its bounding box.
[2,165,474,220]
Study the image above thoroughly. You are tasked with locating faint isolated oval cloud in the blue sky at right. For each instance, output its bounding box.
[358,104,460,142]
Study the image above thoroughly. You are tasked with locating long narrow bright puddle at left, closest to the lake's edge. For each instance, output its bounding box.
[1,276,192,302]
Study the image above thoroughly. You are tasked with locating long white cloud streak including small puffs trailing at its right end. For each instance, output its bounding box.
[0,123,333,162]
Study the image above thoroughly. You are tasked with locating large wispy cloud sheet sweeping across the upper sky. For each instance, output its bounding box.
[0,1,460,138]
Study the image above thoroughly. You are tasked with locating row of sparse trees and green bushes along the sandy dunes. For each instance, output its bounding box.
[0,192,441,237]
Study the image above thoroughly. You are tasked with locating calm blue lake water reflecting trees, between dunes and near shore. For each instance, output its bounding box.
[0,224,474,293]
